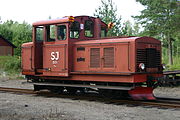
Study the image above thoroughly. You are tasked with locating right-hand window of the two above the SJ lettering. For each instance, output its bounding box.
[57,25,66,40]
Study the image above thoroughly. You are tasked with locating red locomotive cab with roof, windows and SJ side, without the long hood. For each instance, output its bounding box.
[22,16,107,77]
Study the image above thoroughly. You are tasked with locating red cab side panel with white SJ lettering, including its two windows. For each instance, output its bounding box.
[43,25,69,76]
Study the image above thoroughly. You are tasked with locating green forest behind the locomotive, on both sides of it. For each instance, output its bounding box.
[0,0,180,74]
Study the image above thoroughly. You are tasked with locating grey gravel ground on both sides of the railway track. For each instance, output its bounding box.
[0,78,180,120]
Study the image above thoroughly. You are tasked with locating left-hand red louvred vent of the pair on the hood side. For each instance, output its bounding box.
[90,48,100,68]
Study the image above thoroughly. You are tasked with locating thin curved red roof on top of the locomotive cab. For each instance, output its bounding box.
[33,16,100,26]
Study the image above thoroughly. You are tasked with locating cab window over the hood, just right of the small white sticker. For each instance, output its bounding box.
[85,20,94,37]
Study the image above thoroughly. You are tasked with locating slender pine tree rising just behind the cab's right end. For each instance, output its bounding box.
[94,0,122,36]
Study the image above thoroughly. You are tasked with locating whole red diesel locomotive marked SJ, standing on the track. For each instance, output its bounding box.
[22,16,162,99]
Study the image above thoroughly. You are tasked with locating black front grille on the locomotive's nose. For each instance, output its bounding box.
[136,48,161,68]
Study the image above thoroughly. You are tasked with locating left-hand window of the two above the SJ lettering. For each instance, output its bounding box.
[46,25,55,42]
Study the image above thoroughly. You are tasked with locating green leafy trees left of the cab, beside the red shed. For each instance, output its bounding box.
[0,20,32,56]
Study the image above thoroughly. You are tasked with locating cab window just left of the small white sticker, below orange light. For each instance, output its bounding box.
[70,21,80,38]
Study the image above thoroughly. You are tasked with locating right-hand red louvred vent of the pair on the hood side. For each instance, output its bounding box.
[103,47,114,68]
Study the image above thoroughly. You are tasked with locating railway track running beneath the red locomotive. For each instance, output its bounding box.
[0,87,180,109]
